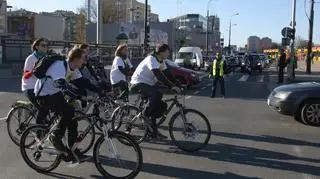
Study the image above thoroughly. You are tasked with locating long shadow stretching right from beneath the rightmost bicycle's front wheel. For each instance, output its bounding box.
[142,143,320,176]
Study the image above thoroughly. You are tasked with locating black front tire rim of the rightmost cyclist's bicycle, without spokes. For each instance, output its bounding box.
[169,109,212,152]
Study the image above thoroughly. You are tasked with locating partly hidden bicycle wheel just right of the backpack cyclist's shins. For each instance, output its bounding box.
[78,118,96,154]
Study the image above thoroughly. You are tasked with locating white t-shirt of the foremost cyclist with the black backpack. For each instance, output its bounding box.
[34,60,82,96]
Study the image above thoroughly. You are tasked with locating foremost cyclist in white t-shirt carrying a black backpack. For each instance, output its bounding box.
[34,48,87,161]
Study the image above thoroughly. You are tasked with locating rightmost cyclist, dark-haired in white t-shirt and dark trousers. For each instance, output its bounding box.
[130,44,180,139]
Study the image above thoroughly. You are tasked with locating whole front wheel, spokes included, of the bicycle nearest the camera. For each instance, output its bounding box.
[93,131,143,179]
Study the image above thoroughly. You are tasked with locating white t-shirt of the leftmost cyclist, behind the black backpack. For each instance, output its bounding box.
[21,54,38,91]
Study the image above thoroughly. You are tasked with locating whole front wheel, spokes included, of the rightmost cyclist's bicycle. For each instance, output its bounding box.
[169,109,211,152]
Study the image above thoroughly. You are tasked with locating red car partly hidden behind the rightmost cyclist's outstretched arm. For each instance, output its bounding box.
[165,60,201,87]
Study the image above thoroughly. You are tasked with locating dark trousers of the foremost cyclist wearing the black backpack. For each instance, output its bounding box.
[39,93,78,147]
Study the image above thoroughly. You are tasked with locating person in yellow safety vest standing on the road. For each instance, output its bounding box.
[209,53,227,98]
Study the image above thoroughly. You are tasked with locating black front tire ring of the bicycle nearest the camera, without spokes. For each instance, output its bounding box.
[93,131,143,179]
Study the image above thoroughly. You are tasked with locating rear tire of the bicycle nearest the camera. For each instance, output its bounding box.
[20,125,62,173]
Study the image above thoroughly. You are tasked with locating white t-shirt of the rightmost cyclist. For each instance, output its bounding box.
[131,55,167,86]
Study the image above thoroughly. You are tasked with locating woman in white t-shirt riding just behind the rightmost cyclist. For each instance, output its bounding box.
[110,45,133,97]
